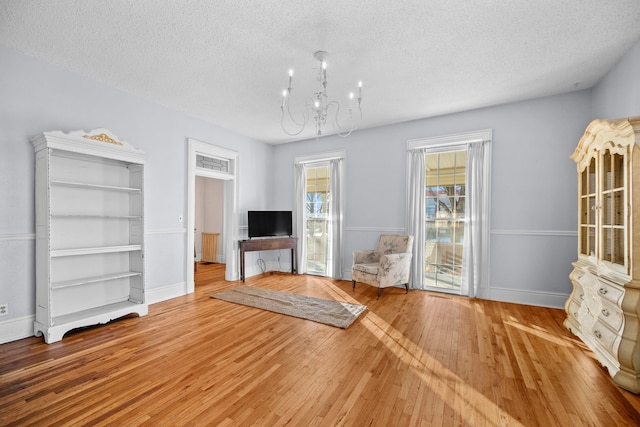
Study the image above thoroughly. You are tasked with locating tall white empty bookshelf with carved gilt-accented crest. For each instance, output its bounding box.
[32,129,148,343]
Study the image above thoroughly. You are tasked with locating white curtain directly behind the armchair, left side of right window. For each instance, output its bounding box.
[407,149,426,289]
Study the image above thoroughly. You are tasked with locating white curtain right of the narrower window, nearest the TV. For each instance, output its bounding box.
[327,159,344,279]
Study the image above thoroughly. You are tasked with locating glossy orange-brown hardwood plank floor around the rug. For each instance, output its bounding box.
[0,264,640,426]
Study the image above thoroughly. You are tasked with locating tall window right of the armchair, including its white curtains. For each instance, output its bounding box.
[407,130,491,296]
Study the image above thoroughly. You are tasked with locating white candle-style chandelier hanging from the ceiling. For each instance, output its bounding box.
[280,50,362,138]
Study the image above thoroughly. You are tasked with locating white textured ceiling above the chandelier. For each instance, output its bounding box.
[0,0,640,143]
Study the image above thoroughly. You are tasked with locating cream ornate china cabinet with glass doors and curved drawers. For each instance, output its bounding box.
[565,117,640,393]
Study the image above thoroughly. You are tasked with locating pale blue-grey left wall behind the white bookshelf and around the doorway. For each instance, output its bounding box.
[0,46,273,342]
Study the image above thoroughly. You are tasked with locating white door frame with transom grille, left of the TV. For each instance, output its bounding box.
[190,138,240,294]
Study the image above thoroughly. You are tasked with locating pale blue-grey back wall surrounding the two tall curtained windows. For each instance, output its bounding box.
[274,91,591,307]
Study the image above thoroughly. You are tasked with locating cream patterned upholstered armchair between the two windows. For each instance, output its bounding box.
[351,234,413,298]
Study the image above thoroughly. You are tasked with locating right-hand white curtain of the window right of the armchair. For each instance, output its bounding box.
[460,141,489,297]
